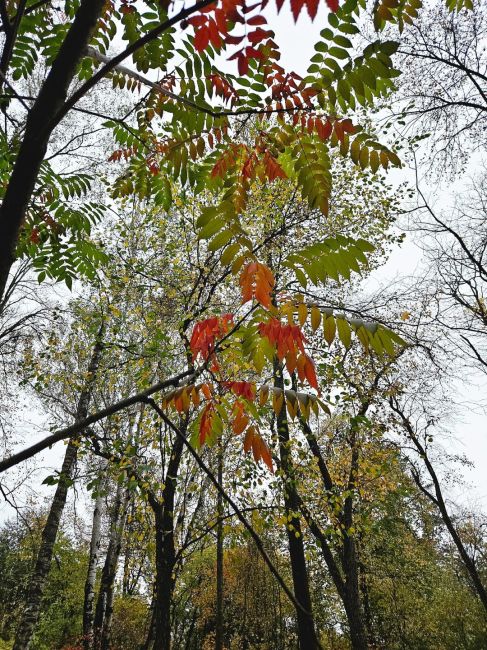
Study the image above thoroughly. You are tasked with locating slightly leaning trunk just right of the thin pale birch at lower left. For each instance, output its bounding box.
[93,483,128,650]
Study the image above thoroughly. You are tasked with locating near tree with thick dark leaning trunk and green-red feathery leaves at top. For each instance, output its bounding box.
[0,0,434,302]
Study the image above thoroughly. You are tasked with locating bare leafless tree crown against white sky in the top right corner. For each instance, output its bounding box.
[396,2,487,174]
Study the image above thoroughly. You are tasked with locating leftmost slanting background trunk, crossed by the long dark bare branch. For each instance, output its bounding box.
[13,326,103,650]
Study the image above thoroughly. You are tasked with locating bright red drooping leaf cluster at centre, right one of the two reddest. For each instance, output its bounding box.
[259,318,319,390]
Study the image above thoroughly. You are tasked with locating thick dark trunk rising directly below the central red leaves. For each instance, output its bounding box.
[274,364,321,650]
